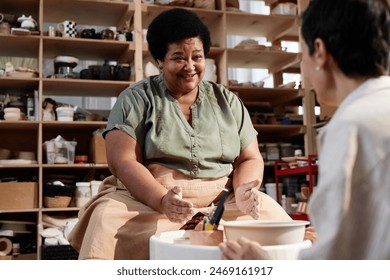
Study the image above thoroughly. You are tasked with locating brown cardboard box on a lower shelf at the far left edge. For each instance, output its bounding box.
[0,182,38,210]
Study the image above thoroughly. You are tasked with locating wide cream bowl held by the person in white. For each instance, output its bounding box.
[220,220,309,246]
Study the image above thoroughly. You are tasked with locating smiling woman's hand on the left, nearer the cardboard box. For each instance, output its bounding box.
[161,186,195,224]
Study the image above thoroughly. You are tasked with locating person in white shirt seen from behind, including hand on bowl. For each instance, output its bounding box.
[220,0,390,259]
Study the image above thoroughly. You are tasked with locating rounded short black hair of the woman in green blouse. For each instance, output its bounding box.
[146,8,211,60]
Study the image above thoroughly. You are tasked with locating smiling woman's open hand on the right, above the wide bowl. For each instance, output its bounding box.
[235,180,261,220]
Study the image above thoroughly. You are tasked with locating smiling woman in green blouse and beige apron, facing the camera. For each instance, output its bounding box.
[69,8,291,259]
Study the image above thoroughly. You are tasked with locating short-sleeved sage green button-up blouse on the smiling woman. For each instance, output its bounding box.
[103,75,257,178]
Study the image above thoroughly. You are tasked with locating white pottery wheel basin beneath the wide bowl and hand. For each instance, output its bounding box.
[149,230,311,260]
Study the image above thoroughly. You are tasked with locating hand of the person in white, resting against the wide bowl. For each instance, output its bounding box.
[219,237,270,260]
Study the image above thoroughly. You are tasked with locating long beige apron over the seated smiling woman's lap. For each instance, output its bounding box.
[68,165,290,260]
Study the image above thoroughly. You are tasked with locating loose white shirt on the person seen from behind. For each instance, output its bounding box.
[299,76,390,259]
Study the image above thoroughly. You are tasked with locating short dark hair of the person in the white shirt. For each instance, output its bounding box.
[301,0,390,77]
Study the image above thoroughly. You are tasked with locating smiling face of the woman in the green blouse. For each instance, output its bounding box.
[159,37,206,95]
